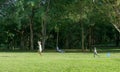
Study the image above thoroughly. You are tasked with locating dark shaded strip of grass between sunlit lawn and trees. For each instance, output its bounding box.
[0,48,120,53]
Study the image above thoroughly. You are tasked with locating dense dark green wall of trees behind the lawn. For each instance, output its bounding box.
[0,0,120,51]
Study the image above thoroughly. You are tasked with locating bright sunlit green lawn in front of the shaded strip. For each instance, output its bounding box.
[0,52,120,72]
